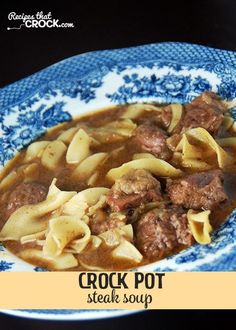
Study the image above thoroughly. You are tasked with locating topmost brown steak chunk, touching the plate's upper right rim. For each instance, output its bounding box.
[180,92,226,135]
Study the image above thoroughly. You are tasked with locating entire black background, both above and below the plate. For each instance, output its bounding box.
[0,0,236,330]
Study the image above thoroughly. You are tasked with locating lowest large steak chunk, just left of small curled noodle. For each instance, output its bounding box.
[135,206,194,260]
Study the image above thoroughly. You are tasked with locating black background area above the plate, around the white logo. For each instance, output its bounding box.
[0,0,236,87]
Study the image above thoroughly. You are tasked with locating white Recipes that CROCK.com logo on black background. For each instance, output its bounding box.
[7,11,75,30]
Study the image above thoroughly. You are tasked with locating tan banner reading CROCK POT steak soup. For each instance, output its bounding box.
[0,272,236,309]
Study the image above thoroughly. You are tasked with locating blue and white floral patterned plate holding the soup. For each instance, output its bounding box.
[0,42,236,320]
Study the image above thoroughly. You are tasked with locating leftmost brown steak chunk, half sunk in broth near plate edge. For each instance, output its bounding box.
[6,182,47,218]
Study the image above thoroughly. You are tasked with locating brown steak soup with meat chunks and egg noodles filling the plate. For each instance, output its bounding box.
[0,92,236,270]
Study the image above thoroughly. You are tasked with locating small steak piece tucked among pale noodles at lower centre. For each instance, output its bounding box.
[89,210,126,235]
